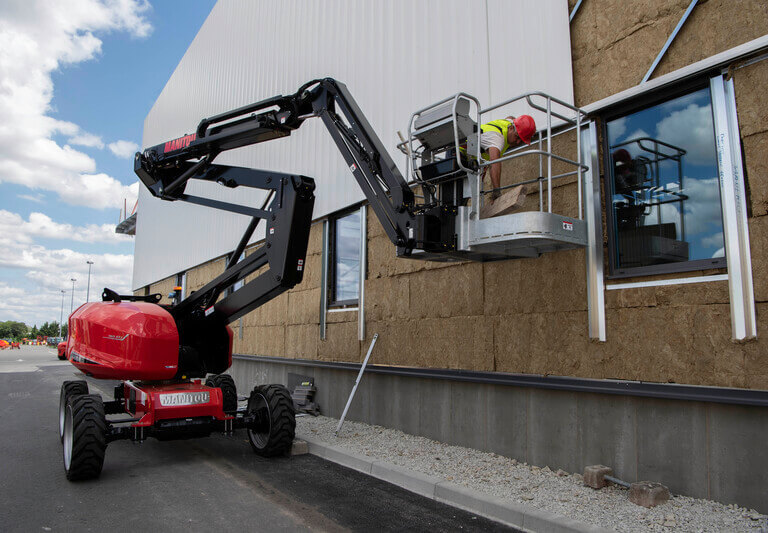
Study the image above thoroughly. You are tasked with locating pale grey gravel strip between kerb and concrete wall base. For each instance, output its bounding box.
[296,416,768,533]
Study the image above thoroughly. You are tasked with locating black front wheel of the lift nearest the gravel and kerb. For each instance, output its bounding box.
[248,385,296,457]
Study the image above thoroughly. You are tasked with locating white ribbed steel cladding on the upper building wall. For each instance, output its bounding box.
[133,0,573,289]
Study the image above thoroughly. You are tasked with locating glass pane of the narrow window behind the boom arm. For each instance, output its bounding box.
[333,212,360,301]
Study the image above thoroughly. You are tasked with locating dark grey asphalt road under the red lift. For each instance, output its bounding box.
[0,346,510,532]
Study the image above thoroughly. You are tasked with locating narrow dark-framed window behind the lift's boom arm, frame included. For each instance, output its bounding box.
[328,210,361,307]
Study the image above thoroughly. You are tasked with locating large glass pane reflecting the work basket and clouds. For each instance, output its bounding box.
[608,88,725,269]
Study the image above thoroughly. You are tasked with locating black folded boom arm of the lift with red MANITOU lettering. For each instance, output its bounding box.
[134,78,444,325]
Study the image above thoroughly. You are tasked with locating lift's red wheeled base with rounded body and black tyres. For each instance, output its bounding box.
[59,297,295,480]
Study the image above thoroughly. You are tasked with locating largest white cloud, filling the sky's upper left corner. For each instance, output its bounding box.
[0,0,151,208]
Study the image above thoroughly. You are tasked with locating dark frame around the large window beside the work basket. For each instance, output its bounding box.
[600,78,728,279]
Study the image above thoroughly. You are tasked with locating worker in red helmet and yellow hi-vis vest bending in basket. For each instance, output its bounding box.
[480,115,536,203]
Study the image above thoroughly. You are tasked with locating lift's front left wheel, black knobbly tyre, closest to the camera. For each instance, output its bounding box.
[63,394,107,481]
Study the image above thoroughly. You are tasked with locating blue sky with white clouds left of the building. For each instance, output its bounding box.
[0,0,215,326]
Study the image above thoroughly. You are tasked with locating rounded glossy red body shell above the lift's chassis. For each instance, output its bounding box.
[67,302,179,381]
